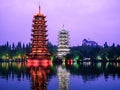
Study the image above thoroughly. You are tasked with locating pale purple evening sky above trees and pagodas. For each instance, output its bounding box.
[0,0,120,46]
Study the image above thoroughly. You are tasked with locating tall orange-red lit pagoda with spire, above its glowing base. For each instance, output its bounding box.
[29,6,50,60]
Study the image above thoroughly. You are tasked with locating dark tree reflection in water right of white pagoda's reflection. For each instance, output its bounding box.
[66,62,120,81]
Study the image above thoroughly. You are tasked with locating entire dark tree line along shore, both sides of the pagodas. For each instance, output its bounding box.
[0,42,120,61]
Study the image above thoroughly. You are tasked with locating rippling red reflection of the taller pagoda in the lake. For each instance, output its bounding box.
[28,62,51,90]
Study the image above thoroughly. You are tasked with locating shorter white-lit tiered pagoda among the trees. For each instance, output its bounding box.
[57,28,70,58]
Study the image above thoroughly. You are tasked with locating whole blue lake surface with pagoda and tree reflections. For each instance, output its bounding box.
[0,62,120,90]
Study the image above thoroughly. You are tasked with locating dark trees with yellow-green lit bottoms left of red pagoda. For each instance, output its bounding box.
[0,42,30,60]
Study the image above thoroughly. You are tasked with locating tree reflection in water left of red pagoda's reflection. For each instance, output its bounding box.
[0,62,30,80]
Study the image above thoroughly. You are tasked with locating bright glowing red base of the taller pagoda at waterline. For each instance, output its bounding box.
[27,59,52,68]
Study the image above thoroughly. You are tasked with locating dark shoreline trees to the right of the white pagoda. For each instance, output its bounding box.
[66,42,120,61]
